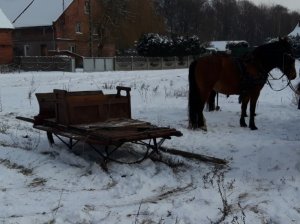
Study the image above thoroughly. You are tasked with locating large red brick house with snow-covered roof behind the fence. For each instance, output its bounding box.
[0,0,110,56]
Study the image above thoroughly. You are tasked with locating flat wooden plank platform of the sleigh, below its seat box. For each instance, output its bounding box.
[34,119,182,144]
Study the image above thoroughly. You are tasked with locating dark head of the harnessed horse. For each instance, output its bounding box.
[274,38,297,80]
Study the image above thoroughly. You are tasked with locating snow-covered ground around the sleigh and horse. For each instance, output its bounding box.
[0,62,300,224]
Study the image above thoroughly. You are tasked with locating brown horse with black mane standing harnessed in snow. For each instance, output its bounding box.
[189,38,296,130]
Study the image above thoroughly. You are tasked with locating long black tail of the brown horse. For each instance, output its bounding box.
[188,61,199,128]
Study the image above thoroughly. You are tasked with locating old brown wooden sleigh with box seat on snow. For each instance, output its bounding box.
[17,86,226,167]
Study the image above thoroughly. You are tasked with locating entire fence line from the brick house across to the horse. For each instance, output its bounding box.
[8,56,194,72]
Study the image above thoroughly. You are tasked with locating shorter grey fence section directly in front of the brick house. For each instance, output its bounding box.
[16,56,75,72]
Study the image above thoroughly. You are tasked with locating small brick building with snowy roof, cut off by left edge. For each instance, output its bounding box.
[0,8,14,65]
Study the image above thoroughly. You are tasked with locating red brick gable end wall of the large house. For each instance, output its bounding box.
[53,0,105,56]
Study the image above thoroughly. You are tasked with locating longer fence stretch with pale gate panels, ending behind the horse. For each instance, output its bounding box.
[83,56,193,72]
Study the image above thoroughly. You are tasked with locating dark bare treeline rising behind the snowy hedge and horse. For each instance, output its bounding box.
[154,0,300,45]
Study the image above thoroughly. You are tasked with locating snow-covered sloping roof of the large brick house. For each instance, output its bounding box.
[0,0,73,27]
